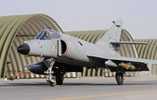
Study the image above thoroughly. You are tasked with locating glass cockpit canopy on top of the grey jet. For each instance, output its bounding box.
[35,29,61,40]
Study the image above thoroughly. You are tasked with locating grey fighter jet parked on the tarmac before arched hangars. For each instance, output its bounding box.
[17,19,157,86]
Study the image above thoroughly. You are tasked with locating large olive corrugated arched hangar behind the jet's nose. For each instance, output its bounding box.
[0,14,62,78]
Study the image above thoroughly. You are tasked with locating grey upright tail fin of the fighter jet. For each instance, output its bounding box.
[96,19,122,46]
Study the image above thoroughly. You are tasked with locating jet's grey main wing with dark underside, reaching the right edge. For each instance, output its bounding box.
[88,54,157,72]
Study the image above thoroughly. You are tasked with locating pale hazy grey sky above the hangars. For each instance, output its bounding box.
[0,0,157,39]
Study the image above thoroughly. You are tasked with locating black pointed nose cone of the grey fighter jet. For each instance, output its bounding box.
[17,43,30,55]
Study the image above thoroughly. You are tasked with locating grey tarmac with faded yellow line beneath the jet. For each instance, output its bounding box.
[0,77,157,100]
